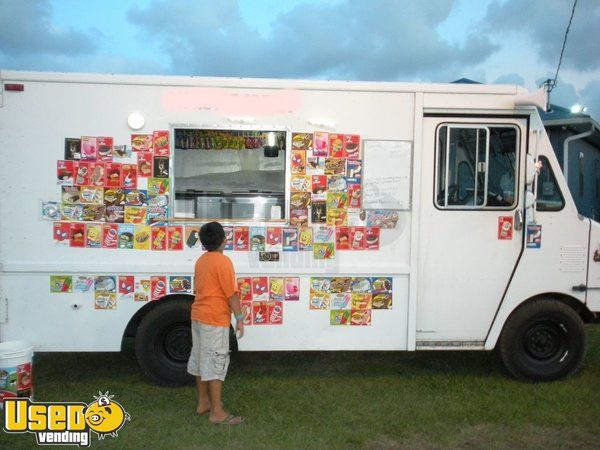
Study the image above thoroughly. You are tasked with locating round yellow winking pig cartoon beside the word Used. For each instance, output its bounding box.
[85,392,131,439]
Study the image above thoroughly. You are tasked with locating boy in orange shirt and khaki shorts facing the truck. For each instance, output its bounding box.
[188,222,244,425]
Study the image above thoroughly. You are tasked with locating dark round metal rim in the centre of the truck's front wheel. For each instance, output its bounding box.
[524,321,566,361]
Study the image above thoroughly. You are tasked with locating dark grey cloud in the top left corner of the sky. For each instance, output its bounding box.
[0,0,96,58]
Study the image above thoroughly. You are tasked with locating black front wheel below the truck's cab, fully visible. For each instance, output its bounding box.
[499,299,587,381]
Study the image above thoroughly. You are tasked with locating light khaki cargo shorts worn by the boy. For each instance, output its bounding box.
[187,320,229,381]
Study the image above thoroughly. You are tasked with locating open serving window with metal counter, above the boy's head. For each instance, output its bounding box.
[173,128,287,220]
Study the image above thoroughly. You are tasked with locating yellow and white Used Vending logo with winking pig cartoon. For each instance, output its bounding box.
[4,392,131,447]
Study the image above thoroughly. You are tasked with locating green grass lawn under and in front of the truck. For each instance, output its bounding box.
[0,326,600,449]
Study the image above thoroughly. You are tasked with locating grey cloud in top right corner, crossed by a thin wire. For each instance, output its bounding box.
[484,0,600,70]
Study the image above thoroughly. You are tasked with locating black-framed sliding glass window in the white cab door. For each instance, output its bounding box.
[435,125,519,209]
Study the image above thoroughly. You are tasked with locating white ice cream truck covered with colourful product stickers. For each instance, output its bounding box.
[0,71,600,384]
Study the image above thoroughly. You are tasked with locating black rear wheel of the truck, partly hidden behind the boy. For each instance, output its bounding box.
[135,298,194,386]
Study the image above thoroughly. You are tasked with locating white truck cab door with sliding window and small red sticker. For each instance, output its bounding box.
[416,115,528,348]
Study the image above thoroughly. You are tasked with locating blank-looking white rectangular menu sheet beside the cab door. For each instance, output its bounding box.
[363,140,412,210]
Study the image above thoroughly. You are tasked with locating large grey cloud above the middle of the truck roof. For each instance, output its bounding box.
[128,0,497,80]
